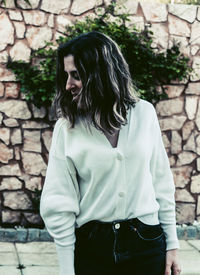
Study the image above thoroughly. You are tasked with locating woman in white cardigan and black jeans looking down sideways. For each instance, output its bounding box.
[41,32,180,275]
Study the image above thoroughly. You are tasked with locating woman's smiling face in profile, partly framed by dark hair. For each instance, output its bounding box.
[64,55,82,102]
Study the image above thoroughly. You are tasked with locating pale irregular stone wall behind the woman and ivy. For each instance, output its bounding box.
[0,0,200,227]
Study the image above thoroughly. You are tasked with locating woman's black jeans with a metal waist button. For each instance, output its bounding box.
[75,218,166,275]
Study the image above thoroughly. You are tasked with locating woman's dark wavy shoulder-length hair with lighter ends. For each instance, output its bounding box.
[53,31,139,133]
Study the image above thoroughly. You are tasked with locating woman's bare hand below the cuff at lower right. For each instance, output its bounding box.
[165,249,181,275]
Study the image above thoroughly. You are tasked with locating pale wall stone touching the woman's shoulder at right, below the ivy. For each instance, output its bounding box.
[156,98,184,116]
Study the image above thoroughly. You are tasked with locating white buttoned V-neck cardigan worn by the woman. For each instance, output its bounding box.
[40,99,179,275]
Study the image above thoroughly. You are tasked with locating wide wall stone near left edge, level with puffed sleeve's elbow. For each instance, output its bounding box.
[3,191,32,210]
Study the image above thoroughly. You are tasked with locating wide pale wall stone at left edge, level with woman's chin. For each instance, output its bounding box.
[0,99,31,119]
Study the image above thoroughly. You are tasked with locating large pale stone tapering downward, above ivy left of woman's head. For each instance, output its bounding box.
[26,27,52,50]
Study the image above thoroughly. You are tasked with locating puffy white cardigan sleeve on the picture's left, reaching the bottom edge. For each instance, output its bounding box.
[40,119,79,275]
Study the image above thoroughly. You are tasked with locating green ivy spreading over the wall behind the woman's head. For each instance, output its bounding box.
[7,4,191,107]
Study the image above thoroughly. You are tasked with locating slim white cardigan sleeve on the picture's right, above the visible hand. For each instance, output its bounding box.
[150,106,179,250]
